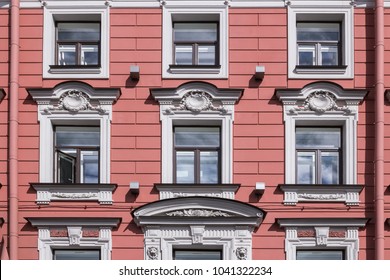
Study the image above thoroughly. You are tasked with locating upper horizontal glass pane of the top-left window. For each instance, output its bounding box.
[57,22,100,42]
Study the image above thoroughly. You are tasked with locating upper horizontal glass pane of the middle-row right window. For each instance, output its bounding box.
[295,127,341,149]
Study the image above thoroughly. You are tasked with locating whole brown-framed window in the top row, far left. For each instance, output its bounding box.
[52,22,100,67]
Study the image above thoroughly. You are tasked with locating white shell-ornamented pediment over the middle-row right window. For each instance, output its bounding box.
[276,82,367,115]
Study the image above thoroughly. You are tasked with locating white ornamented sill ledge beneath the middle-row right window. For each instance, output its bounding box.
[279,184,364,206]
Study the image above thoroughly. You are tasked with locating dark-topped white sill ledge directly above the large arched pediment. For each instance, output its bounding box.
[154,184,240,199]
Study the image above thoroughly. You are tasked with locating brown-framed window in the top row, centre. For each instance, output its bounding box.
[173,22,219,66]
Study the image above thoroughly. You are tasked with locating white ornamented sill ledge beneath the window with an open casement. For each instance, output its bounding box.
[30,183,117,204]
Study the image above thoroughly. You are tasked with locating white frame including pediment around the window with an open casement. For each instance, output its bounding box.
[29,82,120,184]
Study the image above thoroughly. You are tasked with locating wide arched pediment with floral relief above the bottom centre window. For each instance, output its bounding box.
[132,197,265,227]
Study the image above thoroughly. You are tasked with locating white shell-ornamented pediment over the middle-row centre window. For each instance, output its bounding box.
[150,82,243,115]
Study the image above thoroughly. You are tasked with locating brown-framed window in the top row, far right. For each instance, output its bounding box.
[297,22,341,66]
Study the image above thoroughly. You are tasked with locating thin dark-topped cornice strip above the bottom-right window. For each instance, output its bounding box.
[276,218,368,228]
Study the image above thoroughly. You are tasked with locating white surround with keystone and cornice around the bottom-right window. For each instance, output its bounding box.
[277,218,367,260]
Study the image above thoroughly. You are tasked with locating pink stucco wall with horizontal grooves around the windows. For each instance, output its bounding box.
[0,5,390,259]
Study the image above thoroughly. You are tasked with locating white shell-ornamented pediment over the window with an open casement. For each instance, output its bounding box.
[28,82,120,118]
